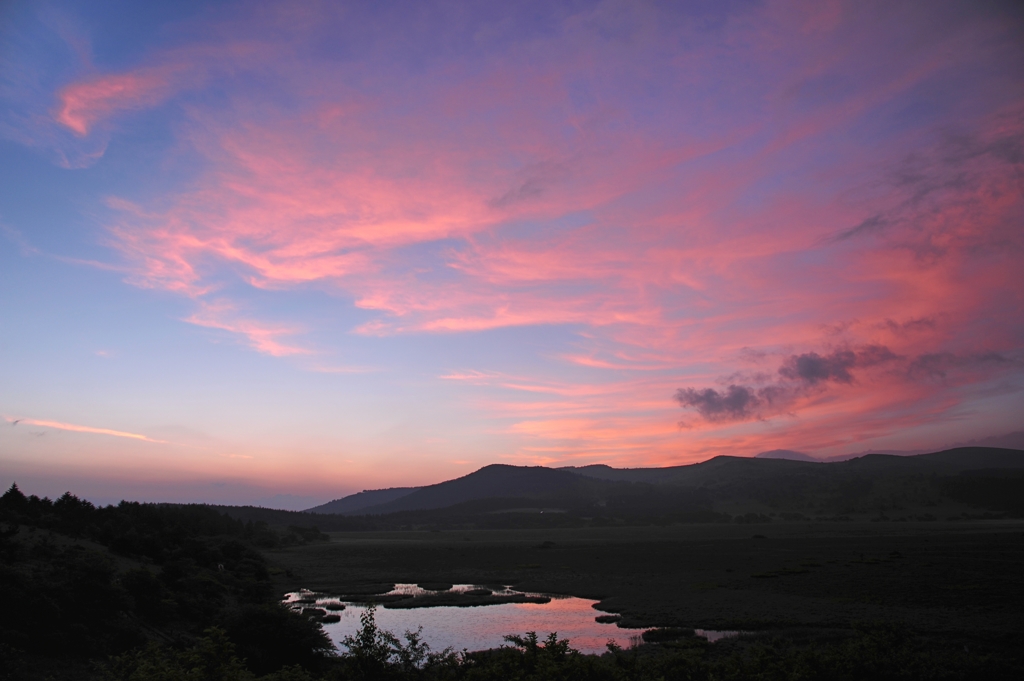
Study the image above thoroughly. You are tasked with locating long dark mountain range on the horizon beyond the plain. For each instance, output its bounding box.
[299,446,1024,526]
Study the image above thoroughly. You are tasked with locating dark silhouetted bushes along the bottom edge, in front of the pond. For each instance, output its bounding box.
[90,610,1020,681]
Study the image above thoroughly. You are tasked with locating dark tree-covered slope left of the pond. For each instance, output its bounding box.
[0,485,331,678]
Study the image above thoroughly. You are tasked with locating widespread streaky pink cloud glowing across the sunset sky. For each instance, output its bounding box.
[44,3,1024,462]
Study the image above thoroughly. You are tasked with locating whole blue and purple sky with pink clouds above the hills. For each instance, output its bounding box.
[0,0,1024,508]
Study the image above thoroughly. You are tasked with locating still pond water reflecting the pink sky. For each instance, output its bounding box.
[285,584,641,654]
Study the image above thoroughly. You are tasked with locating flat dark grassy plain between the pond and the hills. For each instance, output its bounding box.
[267,520,1024,646]
